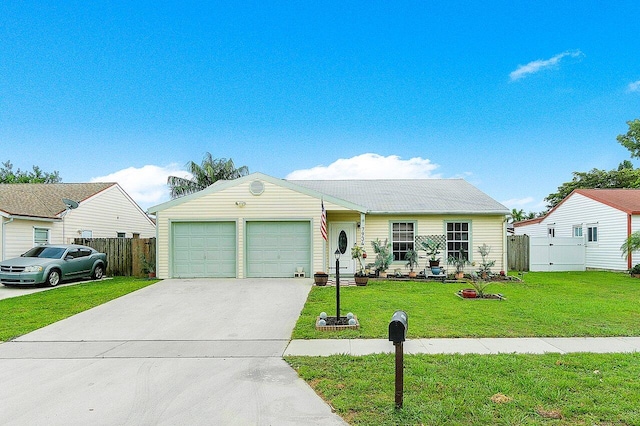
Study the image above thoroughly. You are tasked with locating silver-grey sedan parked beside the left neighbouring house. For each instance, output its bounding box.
[0,244,107,287]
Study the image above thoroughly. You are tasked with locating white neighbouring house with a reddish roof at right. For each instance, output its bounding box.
[514,189,640,271]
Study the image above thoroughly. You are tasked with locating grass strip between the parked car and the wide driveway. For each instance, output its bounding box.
[0,277,159,341]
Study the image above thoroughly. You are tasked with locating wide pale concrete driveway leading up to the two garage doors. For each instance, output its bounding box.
[0,279,345,425]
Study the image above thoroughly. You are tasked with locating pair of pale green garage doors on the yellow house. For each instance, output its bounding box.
[172,221,311,278]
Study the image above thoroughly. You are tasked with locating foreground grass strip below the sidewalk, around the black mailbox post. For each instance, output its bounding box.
[286,353,640,425]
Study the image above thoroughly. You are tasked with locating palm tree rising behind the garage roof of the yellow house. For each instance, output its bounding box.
[167,152,249,198]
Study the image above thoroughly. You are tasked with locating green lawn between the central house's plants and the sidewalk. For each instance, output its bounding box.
[292,272,640,339]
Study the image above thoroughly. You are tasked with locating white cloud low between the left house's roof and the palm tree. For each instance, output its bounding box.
[91,164,191,210]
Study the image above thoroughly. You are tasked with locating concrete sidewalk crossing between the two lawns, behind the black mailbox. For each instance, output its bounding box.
[284,337,640,356]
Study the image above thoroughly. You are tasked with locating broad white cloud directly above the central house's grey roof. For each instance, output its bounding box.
[286,153,440,180]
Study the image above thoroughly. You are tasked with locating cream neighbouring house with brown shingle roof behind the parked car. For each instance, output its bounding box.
[0,183,155,259]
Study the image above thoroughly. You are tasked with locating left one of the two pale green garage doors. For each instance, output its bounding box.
[172,222,236,278]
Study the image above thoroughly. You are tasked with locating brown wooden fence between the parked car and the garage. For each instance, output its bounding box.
[75,238,156,277]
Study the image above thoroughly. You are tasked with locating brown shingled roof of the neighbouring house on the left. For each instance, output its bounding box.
[0,183,116,219]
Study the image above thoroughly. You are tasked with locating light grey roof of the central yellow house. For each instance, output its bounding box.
[149,173,509,215]
